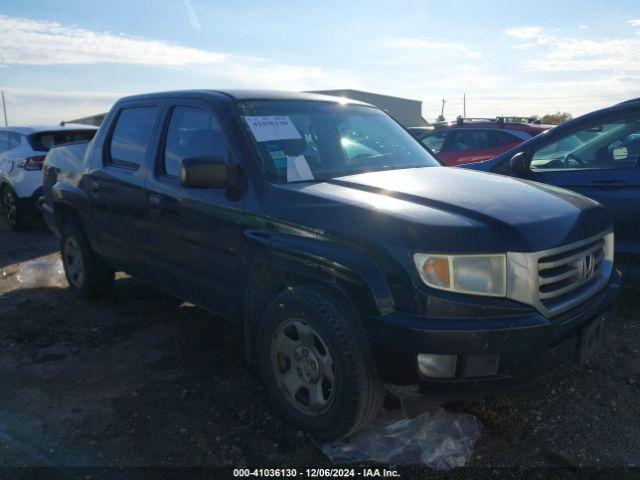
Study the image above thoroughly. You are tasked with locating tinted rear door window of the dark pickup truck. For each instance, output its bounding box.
[109,107,156,168]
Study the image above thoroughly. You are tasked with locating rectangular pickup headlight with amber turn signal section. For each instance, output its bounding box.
[413,253,507,297]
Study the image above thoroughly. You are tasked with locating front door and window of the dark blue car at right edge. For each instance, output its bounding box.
[530,112,640,255]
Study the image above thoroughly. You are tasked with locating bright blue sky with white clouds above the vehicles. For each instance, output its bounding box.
[0,0,640,125]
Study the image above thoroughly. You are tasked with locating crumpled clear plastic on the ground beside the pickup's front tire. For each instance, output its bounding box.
[322,408,482,470]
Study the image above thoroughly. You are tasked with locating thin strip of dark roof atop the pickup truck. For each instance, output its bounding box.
[117,89,372,106]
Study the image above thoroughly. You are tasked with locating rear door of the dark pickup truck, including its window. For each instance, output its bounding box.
[87,102,162,279]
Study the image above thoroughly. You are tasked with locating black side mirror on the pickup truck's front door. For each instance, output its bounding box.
[180,155,238,189]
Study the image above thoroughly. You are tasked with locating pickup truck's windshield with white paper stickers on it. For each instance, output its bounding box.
[238,100,440,183]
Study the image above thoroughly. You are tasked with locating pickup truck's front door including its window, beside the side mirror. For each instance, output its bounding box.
[146,99,244,319]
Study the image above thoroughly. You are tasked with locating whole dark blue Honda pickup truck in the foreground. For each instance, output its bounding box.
[43,91,619,438]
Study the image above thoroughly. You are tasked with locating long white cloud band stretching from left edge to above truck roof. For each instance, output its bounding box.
[0,13,358,94]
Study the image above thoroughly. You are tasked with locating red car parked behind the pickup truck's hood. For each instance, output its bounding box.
[409,118,552,166]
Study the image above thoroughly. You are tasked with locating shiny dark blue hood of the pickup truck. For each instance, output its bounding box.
[270,167,611,253]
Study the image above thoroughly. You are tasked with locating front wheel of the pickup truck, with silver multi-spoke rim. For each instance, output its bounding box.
[257,285,385,440]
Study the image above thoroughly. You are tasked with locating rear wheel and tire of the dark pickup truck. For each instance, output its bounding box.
[60,220,115,300]
